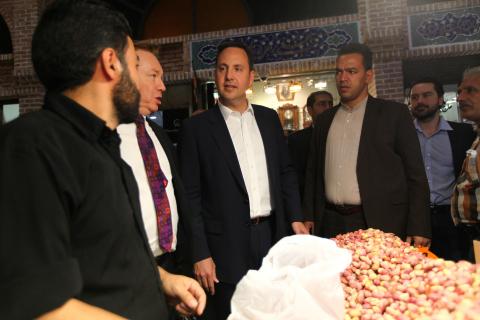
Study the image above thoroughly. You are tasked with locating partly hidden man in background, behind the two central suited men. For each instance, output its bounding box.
[288,91,333,199]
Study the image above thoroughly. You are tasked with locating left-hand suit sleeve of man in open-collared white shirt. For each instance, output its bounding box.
[178,120,211,263]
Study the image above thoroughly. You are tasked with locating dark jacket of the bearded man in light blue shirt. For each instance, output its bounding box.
[448,121,477,178]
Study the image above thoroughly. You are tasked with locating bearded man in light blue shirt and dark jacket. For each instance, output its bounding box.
[410,78,475,261]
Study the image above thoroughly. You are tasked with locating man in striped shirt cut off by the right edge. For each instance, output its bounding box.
[452,66,480,263]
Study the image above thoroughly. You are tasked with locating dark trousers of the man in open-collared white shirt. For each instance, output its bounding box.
[201,218,273,320]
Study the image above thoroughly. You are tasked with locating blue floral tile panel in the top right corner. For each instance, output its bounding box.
[408,7,480,47]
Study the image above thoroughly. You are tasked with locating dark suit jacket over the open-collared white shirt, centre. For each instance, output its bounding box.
[179,105,303,283]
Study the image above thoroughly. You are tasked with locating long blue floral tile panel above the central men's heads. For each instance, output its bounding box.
[191,22,360,70]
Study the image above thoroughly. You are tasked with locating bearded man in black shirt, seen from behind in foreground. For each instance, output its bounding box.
[0,0,205,319]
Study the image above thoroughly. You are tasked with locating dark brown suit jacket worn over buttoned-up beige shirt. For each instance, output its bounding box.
[304,96,431,238]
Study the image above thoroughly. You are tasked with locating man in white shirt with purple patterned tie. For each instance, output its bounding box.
[117,46,189,274]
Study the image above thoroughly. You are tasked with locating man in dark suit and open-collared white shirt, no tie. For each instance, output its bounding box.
[179,43,307,319]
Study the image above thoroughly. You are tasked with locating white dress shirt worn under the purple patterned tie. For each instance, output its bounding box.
[117,121,178,256]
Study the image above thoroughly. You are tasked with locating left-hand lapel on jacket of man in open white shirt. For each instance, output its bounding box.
[209,106,247,194]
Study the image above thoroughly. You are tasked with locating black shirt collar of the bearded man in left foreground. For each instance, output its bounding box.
[43,92,116,141]
